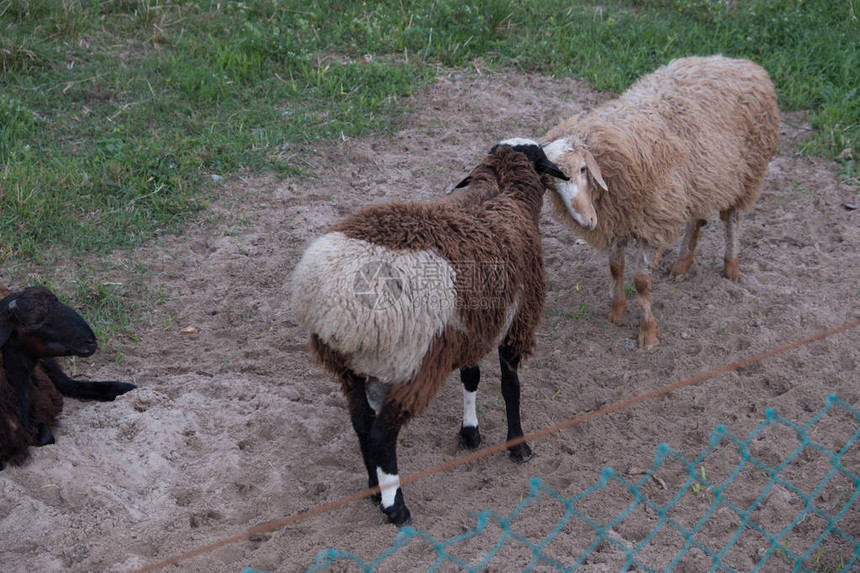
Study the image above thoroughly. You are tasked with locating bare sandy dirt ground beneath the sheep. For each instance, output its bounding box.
[0,72,860,572]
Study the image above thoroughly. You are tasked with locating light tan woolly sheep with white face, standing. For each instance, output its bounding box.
[543,56,779,348]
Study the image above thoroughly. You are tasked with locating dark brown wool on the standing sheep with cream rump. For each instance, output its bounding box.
[311,148,546,416]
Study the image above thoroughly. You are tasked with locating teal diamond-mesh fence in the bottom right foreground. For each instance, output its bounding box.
[298,396,860,573]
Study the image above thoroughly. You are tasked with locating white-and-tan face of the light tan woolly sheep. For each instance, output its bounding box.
[543,139,603,231]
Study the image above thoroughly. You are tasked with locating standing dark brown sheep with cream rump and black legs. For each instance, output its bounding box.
[292,139,565,525]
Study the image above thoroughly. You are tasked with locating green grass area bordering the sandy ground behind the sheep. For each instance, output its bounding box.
[0,0,860,338]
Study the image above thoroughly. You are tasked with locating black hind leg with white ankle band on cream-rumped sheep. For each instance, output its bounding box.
[370,402,412,526]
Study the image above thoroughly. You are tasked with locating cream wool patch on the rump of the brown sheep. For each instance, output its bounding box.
[292,232,462,384]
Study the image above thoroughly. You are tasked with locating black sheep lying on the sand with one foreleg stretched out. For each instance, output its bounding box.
[0,286,137,469]
